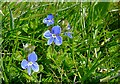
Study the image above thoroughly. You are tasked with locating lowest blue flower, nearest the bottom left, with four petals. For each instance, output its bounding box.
[21,52,39,75]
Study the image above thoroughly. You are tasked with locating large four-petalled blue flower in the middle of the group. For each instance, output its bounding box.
[43,26,62,45]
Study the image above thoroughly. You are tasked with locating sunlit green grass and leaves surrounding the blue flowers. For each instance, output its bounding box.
[0,2,120,84]
